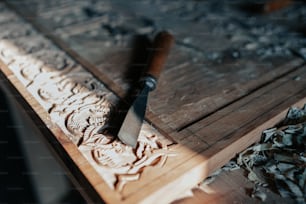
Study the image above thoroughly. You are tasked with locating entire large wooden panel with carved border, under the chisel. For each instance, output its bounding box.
[0,0,306,203]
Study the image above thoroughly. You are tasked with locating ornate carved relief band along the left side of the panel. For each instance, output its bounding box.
[0,9,173,192]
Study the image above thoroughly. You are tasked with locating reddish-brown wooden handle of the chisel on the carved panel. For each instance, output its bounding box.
[147,31,174,80]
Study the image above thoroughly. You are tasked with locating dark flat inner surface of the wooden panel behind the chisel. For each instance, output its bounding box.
[5,1,304,130]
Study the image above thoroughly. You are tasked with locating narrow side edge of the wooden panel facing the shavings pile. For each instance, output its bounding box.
[129,91,306,203]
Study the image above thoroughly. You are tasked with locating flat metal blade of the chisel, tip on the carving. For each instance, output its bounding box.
[118,85,150,148]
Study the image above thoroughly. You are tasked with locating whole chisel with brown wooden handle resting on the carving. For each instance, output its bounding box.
[118,31,174,148]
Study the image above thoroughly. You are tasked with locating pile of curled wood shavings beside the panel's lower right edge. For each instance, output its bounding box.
[201,104,306,203]
